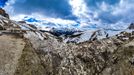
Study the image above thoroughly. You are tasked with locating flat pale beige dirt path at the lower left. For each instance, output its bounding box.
[0,35,25,75]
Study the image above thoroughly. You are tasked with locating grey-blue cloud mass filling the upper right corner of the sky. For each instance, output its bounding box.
[85,0,134,24]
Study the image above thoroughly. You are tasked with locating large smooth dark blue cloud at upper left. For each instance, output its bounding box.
[7,0,75,19]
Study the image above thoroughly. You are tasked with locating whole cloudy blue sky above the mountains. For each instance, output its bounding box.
[0,0,134,29]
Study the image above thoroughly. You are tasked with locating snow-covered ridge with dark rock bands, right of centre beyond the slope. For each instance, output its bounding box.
[61,30,109,43]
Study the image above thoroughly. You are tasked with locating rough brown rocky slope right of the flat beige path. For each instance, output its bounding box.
[17,27,134,75]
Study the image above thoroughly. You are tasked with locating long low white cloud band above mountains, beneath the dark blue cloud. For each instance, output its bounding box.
[11,13,78,30]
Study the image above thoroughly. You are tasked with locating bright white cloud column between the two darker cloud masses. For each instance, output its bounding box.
[69,0,100,27]
